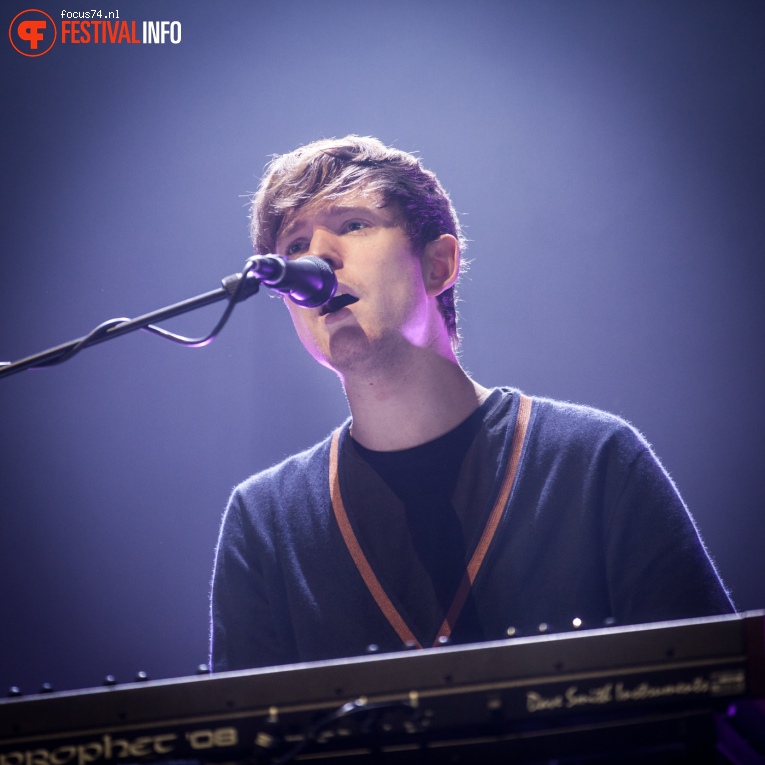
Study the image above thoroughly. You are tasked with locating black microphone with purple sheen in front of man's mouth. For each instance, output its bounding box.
[243,255,337,308]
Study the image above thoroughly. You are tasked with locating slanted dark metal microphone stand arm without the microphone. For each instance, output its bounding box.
[0,273,262,378]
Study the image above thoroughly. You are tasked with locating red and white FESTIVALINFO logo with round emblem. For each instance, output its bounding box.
[8,8,182,58]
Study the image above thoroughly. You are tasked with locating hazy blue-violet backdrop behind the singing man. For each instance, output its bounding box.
[0,0,765,695]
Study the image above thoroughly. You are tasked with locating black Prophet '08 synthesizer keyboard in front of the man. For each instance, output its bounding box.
[0,612,765,765]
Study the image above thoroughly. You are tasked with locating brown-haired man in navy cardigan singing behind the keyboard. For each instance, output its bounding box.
[211,136,733,671]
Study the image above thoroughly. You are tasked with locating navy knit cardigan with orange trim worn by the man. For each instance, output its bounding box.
[210,389,733,671]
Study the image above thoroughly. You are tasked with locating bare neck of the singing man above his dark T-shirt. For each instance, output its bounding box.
[344,350,489,451]
